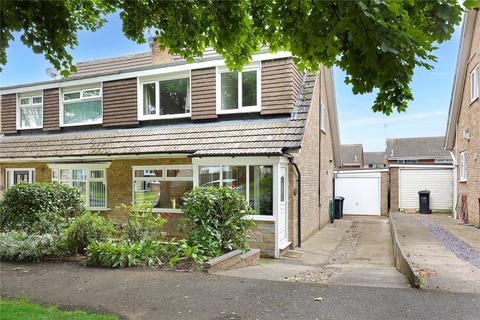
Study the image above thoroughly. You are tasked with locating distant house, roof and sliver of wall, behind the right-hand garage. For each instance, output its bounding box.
[386,137,453,165]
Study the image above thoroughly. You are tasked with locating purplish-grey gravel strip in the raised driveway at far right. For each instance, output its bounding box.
[420,216,480,268]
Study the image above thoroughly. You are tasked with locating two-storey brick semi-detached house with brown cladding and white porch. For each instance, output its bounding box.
[0,45,340,257]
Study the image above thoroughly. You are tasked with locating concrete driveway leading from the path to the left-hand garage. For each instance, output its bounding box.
[221,216,409,288]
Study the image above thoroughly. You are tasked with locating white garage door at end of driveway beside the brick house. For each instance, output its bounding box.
[335,172,380,216]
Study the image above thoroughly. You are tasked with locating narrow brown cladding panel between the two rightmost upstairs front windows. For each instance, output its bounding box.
[191,68,217,120]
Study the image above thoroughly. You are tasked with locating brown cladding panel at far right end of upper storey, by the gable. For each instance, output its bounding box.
[261,58,302,114]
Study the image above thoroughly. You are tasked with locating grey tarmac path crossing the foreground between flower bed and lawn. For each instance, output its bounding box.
[0,263,480,320]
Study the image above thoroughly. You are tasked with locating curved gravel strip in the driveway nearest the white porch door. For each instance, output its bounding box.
[285,221,360,283]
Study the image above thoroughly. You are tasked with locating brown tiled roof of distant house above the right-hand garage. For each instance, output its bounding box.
[387,136,451,160]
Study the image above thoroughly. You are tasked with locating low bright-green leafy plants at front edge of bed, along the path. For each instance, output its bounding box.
[85,239,176,268]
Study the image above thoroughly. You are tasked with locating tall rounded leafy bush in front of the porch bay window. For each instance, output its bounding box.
[180,186,255,257]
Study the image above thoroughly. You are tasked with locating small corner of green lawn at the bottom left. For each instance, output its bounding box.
[0,300,118,320]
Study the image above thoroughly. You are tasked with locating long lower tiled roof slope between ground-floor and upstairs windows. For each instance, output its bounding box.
[0,75,315,159]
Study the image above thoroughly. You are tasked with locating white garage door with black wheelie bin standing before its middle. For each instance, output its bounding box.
[399,168,453,210]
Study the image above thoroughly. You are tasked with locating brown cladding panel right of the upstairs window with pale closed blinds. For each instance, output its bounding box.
[103,78,138,127]
